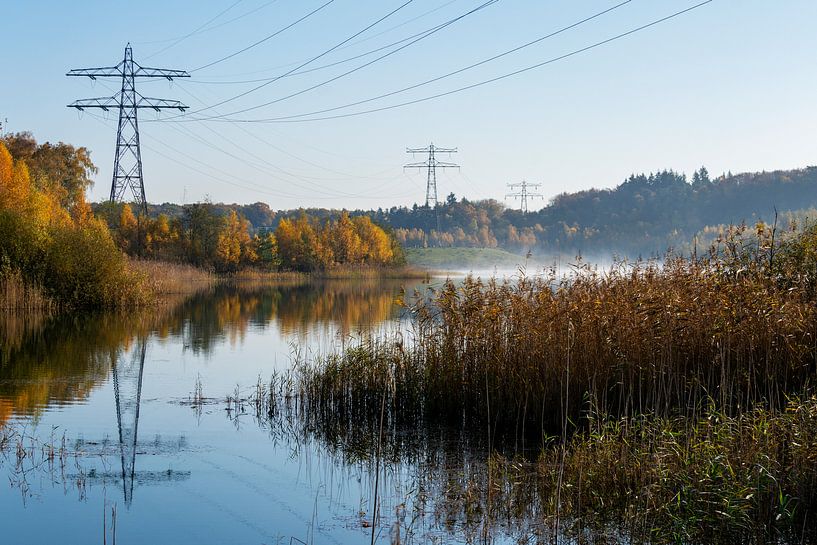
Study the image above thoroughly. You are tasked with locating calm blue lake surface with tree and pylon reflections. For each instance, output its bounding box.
[0,281,536,545]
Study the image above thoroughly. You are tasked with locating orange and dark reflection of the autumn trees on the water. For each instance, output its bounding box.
[0,280,418,425]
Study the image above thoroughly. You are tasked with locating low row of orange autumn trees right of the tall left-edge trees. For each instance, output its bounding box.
[97,202,405,273]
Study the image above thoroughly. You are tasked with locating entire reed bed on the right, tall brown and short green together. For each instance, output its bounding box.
[278,235,817,543]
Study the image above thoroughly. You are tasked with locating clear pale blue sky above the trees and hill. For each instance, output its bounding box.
[0,0,817,209]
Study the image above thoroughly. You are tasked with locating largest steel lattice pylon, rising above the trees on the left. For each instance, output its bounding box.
[66,44,190,213]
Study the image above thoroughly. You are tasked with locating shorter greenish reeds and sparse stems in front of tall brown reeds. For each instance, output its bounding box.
[234,373,817,545]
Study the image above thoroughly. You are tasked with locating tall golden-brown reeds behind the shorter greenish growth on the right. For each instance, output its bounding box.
[298,255,817,440]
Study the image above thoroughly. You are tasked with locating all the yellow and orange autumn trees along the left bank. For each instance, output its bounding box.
[0,133,405,309]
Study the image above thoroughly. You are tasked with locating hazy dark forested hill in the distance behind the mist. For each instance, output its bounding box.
[151,167,817,256]
